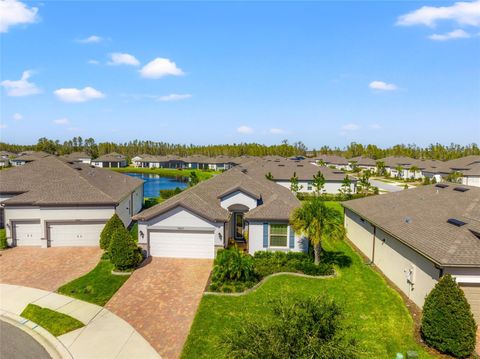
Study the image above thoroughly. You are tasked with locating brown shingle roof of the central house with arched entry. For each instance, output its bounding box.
[134,168,300,222]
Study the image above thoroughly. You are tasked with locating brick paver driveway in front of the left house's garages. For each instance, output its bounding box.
[0,247,102,291]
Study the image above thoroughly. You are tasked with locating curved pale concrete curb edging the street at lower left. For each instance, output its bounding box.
[0,312,73,359]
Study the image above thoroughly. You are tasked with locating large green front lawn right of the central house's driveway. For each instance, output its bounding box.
[182,202,431,358]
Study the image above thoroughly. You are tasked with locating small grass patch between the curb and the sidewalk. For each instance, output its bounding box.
[20,304,84,337]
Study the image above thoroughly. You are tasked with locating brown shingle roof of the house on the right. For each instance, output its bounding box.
[343,183,480,267]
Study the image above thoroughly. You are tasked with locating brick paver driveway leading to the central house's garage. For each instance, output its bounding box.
[106,258,212,359]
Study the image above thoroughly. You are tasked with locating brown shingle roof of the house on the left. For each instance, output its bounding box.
[0,156,143,205]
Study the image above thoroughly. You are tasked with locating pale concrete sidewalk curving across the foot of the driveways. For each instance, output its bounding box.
[0,284,160,359]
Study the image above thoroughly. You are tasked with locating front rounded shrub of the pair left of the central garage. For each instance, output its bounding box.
[109,228,143,271]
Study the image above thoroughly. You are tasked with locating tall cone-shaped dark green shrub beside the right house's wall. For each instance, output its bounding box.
[421,274,477,358]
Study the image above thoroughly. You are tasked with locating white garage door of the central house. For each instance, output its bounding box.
[150,231,215,258]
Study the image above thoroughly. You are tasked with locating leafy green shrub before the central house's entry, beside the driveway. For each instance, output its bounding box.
[212,247,255,283]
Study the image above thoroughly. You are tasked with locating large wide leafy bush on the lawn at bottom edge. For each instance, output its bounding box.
[220,297,358,359]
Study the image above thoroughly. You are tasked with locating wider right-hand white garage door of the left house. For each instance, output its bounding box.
[48,223,105,247]
